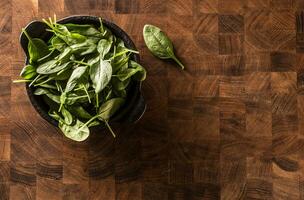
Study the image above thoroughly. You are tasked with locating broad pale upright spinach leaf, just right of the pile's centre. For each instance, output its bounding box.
[90,59,112,94]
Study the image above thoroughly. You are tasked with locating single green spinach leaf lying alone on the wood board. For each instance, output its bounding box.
[143,24,185,69]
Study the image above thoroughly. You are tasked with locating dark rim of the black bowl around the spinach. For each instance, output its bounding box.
[19,15,146,129]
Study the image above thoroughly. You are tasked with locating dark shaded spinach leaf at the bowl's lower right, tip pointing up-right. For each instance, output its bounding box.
[98,98,125,121]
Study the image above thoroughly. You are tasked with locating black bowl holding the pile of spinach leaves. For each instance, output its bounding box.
[20,16,146,129]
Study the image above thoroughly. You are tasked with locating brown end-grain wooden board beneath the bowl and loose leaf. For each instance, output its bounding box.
[0,0,304,200]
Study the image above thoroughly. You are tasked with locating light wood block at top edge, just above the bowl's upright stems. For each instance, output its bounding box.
[38,0,64,13]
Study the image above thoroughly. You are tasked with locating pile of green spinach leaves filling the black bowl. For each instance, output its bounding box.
[15,19,146,141]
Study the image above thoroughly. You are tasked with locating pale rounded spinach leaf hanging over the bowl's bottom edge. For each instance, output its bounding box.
[59,119,90,142]
